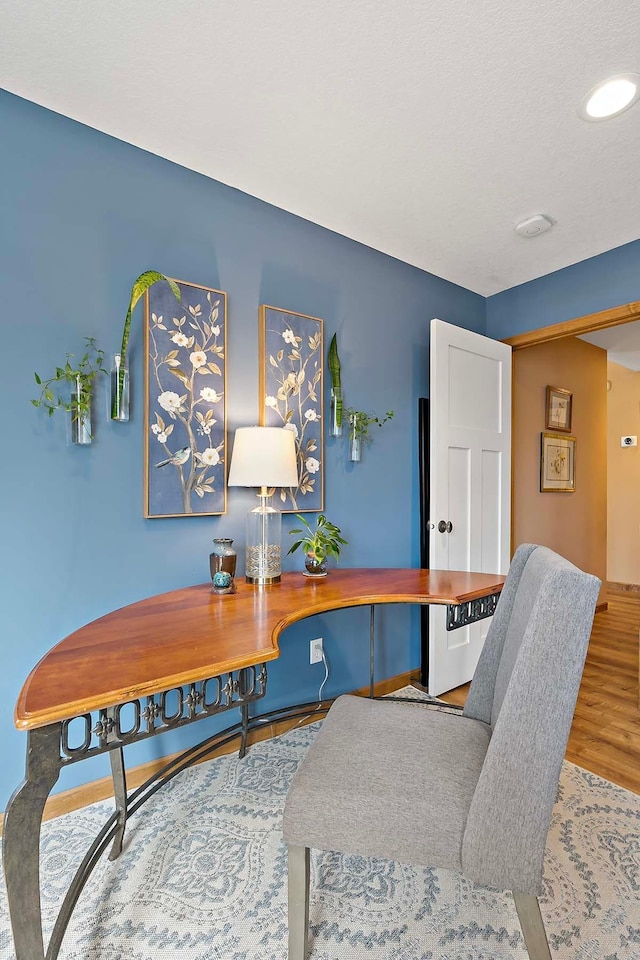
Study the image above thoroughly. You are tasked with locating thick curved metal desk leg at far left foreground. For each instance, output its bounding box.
[2,723,61,960]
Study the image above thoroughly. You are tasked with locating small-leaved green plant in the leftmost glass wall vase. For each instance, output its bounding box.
[31,337,107,432]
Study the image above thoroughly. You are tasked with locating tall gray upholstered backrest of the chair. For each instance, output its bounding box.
[462,544,600,895]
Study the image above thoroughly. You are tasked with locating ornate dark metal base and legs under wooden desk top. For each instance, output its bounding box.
[3,595,497,960]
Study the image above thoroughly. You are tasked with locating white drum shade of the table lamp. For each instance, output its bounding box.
[227,427,298,487]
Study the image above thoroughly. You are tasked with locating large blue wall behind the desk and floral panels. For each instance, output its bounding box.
[0,92,485,805]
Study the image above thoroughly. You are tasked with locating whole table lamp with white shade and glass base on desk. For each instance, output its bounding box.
[228,427,298,584]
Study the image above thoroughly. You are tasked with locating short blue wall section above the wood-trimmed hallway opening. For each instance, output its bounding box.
[486,240,640,340]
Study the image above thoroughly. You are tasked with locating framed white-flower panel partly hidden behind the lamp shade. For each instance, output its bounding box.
[259,304,324,513]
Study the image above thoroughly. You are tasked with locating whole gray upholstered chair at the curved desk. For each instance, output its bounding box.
[284,544,600,960]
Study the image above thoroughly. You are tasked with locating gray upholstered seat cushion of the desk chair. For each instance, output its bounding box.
[284,696,491,870]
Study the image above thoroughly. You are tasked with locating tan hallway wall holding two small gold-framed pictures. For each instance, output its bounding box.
[512,337,608,597]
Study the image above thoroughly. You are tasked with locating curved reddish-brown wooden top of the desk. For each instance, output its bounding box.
[15,569,505,730]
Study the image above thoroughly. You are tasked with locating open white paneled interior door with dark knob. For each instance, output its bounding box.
[429,320,511,696]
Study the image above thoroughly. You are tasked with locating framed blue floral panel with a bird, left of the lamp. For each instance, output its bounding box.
[144,280,227,517]
